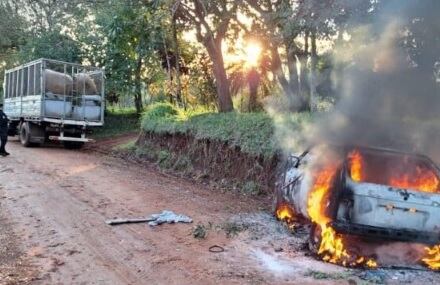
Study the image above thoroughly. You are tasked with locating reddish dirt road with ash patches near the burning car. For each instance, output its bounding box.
[0,138,436,284]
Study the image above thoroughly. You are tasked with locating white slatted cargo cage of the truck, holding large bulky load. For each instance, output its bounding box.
[4,59,104,125]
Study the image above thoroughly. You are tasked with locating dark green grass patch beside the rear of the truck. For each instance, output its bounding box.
[92,109,140,138]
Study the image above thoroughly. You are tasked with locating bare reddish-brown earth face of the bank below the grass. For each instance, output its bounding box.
[137,132,279,194]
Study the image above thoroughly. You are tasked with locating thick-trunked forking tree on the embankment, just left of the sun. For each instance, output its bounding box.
[175,0,241,112]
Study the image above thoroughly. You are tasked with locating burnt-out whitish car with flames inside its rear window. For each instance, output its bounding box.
[275,146,440,244]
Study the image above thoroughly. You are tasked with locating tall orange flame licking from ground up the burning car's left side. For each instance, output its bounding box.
[307,165,377,267]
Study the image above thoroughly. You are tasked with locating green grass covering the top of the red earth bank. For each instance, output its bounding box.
[141,103,311,157]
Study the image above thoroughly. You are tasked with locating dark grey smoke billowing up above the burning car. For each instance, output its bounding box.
[308,0,440,162]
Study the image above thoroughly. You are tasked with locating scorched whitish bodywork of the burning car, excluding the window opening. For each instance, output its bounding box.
[277,148,440,244]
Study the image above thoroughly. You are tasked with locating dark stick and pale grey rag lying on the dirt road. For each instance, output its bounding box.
[105,210,192,226]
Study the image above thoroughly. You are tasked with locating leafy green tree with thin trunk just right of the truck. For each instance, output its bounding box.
[98,0,166,114]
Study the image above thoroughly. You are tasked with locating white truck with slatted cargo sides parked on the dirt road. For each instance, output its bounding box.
[3,58,105,149]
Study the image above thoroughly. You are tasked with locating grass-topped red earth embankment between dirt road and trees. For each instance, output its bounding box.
[118,103,310,194]
